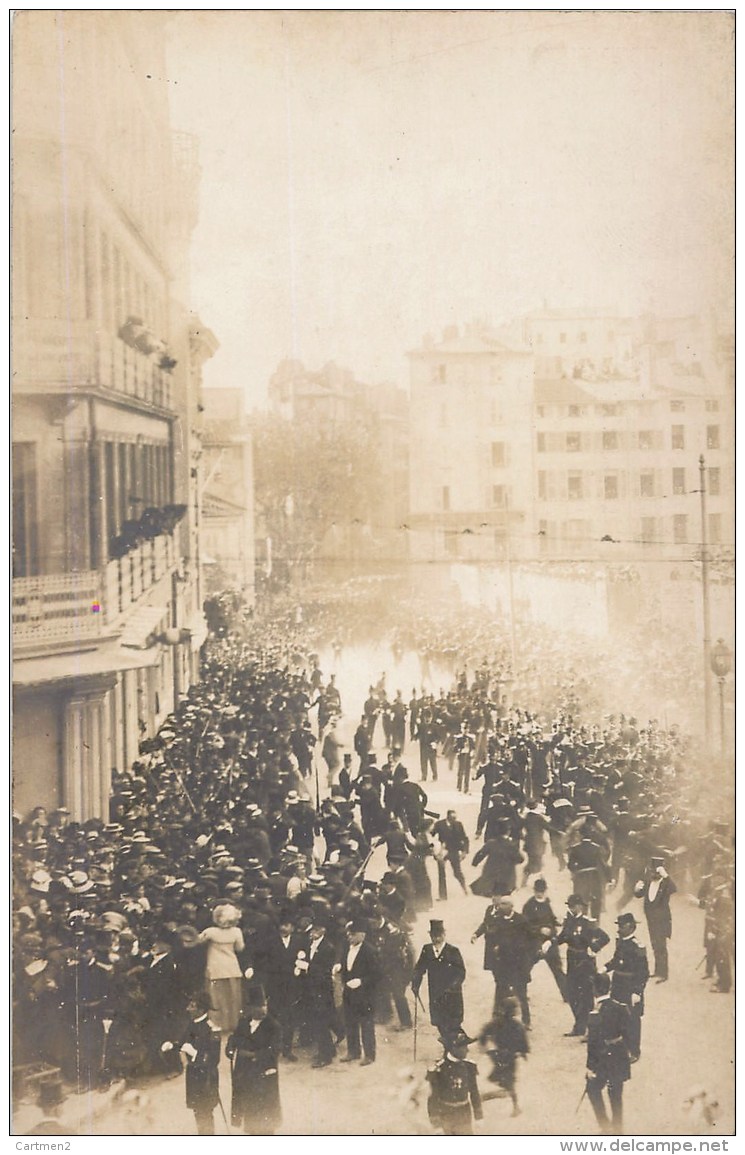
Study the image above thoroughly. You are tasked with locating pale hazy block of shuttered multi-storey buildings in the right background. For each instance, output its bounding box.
[409,311,735,631]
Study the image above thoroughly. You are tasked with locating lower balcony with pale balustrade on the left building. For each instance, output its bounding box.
[13,534,178,654]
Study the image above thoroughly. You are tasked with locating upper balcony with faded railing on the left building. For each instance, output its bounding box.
[14,321,173,409]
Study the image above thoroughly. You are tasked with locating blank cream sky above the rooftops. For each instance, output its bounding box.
[169,10,733,407]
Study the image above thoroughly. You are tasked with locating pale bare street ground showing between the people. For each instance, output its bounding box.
[17,649,735,1135]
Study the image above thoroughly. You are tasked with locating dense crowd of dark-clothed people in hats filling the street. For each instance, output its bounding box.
[13,616,733,1134]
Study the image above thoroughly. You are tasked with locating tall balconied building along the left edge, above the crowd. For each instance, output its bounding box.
[13,12,216,820]
